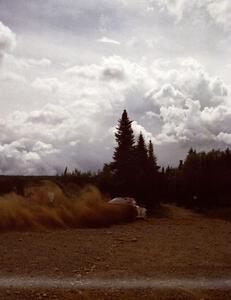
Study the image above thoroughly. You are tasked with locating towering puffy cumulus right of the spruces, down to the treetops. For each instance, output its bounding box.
[143,58,231,147]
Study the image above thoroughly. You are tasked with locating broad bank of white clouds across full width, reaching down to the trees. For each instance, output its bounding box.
[0,56,231,174]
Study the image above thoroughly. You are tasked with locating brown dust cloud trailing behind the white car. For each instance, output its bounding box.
[0,181,136,231]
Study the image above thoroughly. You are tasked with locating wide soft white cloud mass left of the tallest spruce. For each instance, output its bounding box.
[0,56,144,174]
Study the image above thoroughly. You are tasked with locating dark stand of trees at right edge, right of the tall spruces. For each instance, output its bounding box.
[165,148,231,209]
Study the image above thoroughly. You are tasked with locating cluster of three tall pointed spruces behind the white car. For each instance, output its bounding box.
[110,110,159,212]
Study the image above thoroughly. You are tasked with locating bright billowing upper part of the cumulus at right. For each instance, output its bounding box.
[147,58,228,108]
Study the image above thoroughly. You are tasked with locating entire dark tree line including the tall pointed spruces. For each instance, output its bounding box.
[62,110,231,212]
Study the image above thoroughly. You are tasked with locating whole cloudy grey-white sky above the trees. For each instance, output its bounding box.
[0,0,231,175]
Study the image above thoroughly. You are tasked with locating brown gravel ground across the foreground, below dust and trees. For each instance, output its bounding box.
[0,205,231,300]
